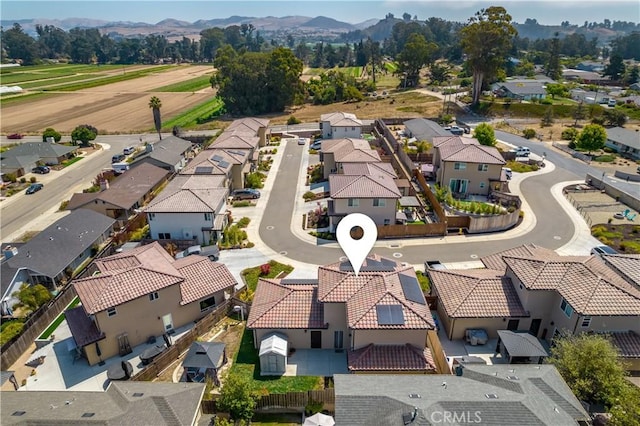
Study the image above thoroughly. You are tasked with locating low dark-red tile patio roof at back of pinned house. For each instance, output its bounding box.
[347,344,436,373]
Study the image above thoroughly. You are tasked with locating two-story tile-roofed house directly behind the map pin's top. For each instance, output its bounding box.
[327,172,402,232]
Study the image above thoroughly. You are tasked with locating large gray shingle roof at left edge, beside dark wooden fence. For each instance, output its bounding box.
[2,209,115,293]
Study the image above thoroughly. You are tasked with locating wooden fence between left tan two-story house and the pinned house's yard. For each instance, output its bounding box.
[131,300,233,381]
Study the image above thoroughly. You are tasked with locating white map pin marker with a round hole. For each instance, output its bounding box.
[336,213,378,276]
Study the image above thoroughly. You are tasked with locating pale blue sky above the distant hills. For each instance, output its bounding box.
[0,0,640,25]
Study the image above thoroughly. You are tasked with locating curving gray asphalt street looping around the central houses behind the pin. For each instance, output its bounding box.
[259,136,584,264]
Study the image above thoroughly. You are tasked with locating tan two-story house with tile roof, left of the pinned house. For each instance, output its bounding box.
[66,242,237,365]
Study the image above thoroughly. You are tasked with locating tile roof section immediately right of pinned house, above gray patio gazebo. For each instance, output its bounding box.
[428,269,529,318]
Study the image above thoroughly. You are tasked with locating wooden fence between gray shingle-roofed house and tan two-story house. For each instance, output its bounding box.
[0,286,76,371]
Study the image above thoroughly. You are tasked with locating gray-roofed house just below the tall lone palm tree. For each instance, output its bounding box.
[131,135,194,173]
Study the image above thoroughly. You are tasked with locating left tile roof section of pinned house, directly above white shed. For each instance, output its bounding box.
[247,278,327,329]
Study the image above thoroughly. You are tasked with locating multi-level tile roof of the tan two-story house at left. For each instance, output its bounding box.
[74,242,236,314]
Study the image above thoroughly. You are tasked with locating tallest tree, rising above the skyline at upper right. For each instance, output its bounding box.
[460,6,517,104]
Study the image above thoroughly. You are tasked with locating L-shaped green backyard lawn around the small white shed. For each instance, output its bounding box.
[229,329,324,393]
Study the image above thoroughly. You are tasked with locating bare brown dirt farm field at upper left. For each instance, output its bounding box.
[1,65,214,133]
